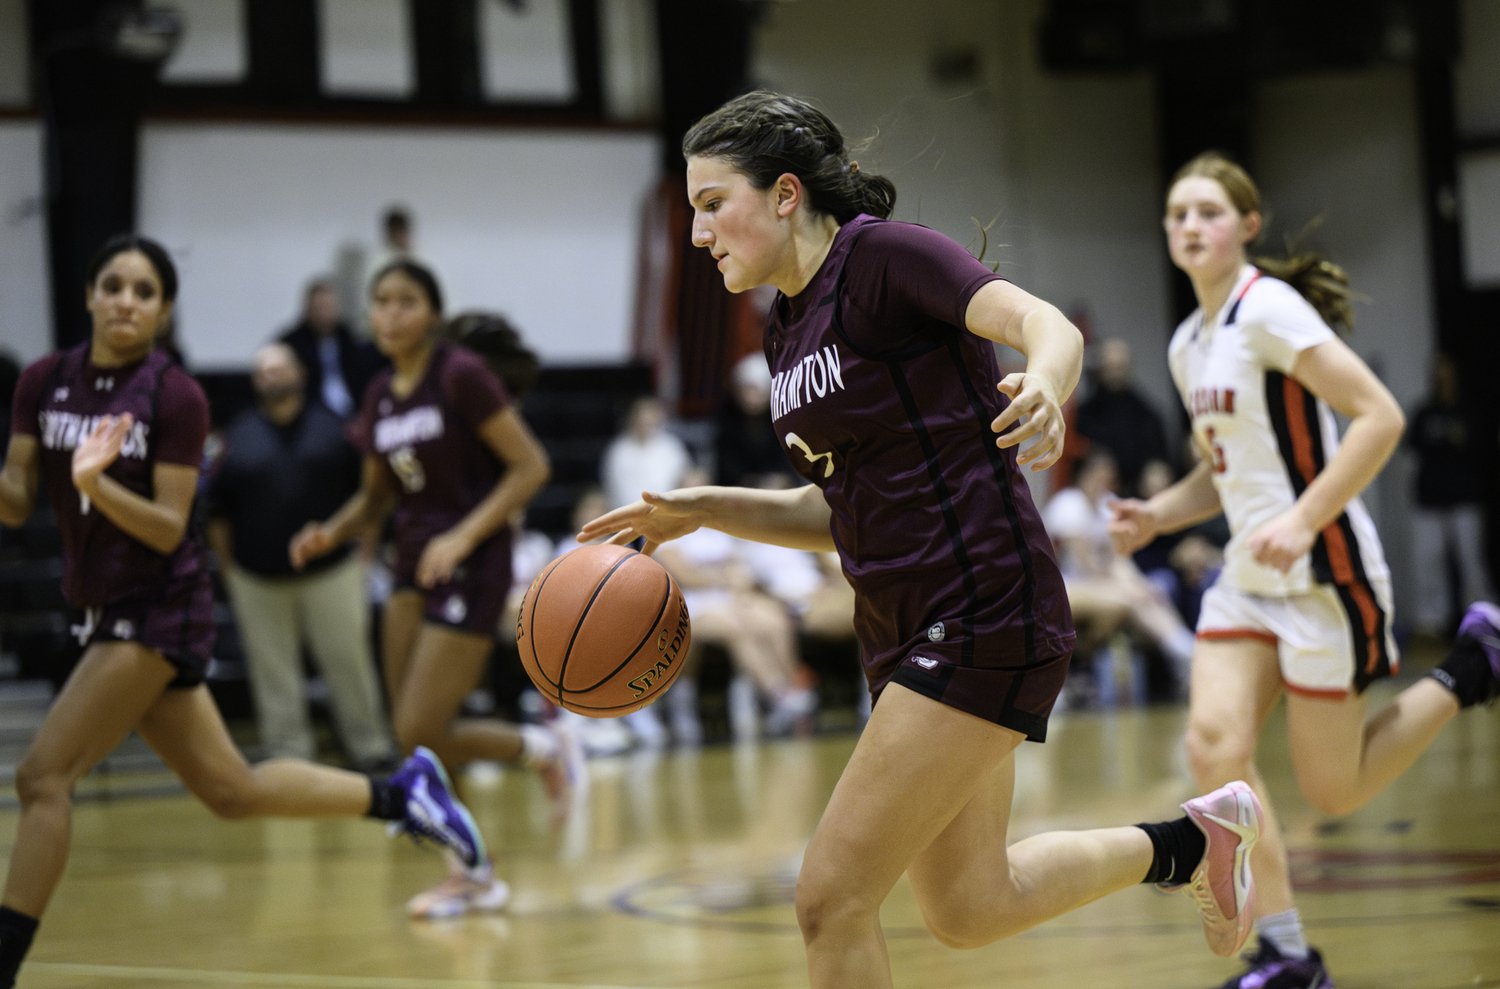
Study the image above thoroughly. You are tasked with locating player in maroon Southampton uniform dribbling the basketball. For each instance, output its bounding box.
[581,93,1259,989]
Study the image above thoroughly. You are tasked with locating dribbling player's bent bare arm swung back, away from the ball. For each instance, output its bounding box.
[965,282,1083,470]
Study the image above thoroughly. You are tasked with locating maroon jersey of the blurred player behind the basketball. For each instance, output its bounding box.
[351,344,510,578]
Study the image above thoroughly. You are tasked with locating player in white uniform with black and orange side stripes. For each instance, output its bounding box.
[1113,153,1500,989]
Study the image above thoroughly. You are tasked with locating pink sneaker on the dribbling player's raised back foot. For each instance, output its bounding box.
[1161,780,1263,957]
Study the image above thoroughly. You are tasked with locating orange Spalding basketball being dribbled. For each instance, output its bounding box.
[516,545,692,717]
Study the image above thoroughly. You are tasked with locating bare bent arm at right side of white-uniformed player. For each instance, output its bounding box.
[1247,339,1406,572]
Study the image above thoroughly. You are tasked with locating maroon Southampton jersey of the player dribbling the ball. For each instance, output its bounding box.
[765,215,1073,690]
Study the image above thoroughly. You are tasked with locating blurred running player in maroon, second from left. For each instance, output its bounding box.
[290,260,584,917]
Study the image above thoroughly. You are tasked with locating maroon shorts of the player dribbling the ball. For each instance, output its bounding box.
[890,648,1073,741]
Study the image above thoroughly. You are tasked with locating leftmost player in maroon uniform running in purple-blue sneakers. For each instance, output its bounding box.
[0,237,486,986]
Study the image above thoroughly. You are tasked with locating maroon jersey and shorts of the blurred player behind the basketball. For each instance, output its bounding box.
[351,344,510,635]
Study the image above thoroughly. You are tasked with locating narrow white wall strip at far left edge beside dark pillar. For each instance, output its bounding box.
[0,120,52,363]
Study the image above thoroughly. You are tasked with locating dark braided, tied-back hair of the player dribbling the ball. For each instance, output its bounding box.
[683,90,896,224]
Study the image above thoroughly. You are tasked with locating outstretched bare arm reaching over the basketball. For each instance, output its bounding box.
[578,485,834,554]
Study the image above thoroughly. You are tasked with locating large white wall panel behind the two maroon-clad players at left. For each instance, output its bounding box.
[140,122,659,368]
